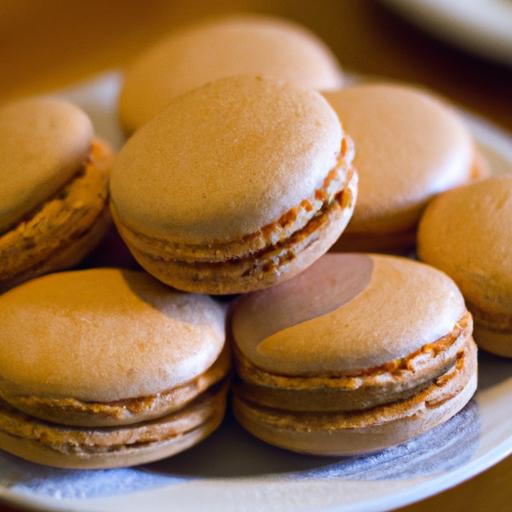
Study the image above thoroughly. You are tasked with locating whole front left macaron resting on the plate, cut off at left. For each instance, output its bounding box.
[0,268,230,469]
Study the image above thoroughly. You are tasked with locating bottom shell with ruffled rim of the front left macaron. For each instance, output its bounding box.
[0,384,227,469]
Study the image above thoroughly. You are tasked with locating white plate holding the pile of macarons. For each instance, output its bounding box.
[0,74,512,512]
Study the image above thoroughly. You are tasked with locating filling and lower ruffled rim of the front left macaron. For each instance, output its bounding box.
[0,384,227,456]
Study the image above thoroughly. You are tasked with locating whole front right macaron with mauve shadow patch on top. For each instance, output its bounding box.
[231,253,477,455]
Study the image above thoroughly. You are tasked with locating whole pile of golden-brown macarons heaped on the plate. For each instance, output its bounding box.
[0,16,512,468]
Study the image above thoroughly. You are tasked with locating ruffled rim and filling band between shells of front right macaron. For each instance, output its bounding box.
[235,313,473,411]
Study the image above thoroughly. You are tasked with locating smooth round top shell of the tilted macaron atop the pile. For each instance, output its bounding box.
[111,75,342,243]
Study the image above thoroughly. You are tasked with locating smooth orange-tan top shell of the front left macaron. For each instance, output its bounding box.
[0,269,225,402]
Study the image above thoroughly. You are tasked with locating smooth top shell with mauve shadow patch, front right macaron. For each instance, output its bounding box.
[232,253,466,376]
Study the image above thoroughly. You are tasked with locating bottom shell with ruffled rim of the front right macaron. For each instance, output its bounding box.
[233,339,477,456]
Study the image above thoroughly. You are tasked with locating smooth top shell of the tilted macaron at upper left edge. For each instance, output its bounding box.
[0,98,93,231]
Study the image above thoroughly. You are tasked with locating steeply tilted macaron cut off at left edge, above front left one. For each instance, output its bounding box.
[0,98,112,290]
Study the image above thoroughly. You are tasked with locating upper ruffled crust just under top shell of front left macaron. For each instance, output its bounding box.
[0,345,231,427]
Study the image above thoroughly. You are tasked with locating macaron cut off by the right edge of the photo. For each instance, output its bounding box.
[418,175,512,357]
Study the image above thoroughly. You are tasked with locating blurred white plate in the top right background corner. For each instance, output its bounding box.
[385,0,512,64]
